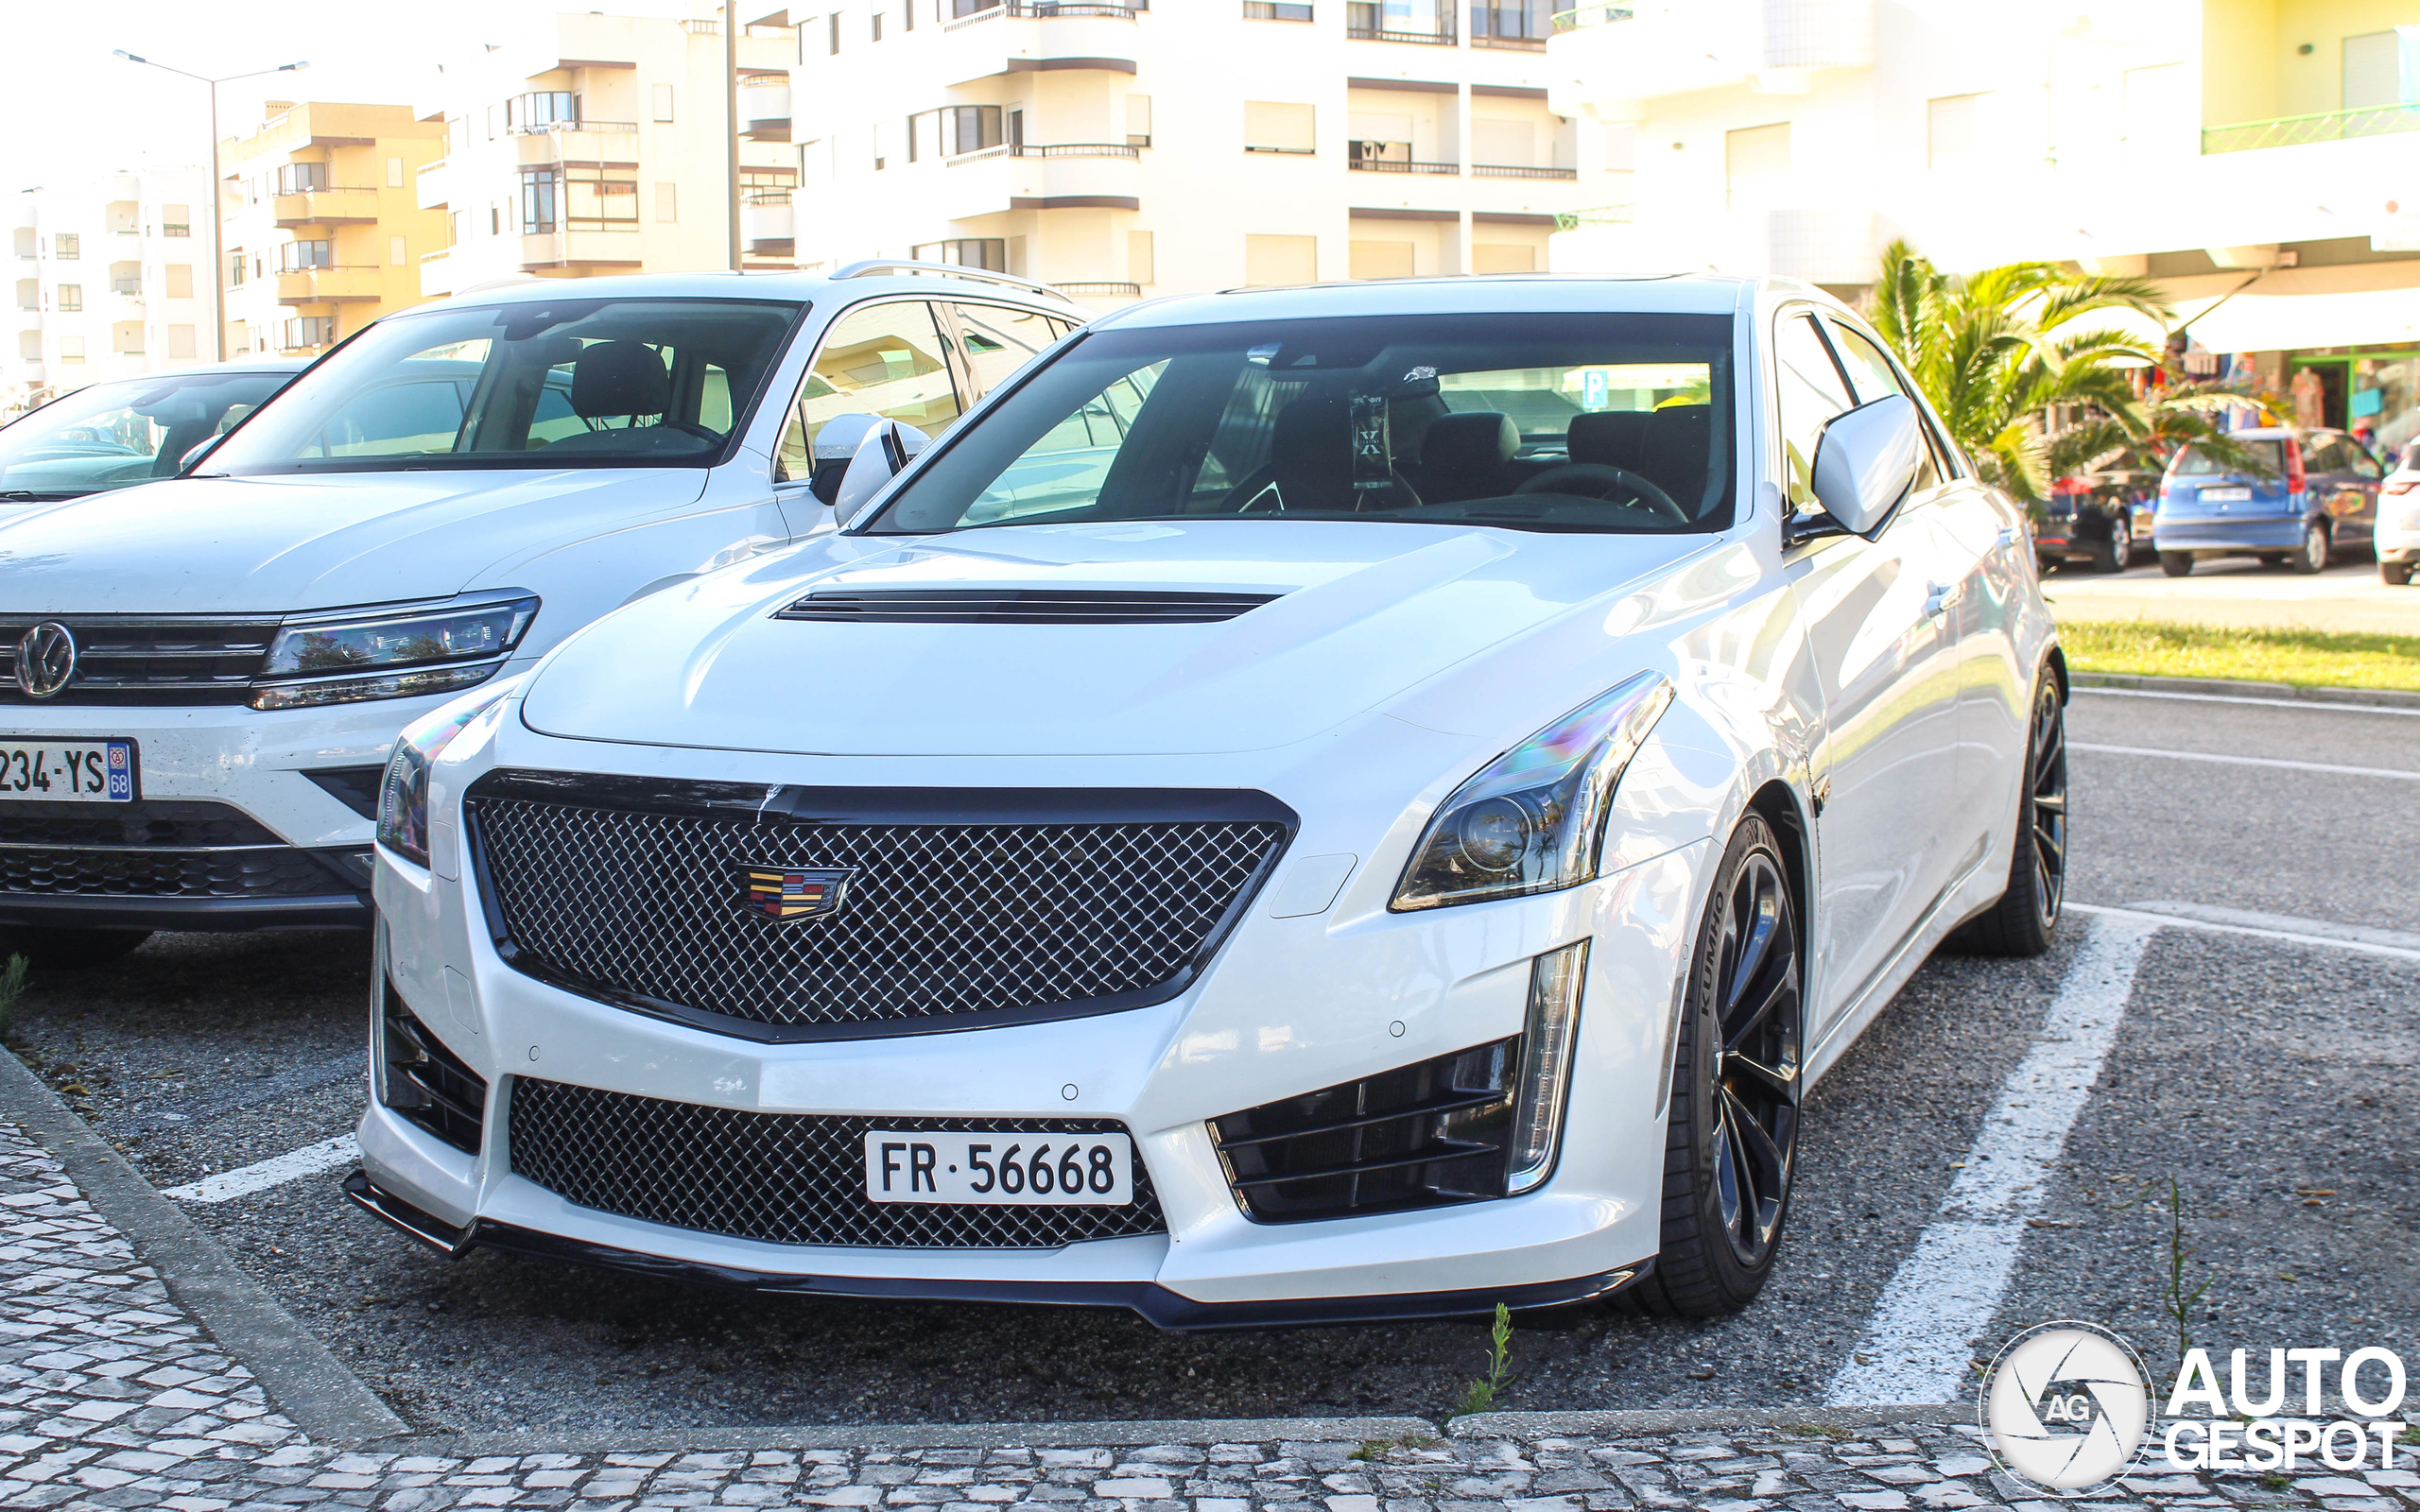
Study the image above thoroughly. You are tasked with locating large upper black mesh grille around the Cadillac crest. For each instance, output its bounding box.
[467,774,1289,1038]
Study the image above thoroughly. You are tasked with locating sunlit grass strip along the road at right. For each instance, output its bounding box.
[2060,619,2420,692]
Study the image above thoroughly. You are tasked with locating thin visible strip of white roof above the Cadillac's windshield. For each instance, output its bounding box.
[1092,273,1761,332]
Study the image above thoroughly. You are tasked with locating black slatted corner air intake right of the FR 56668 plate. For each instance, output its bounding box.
[1210,1038,1520,1224]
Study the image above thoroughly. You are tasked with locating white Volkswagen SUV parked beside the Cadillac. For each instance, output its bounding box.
[0,264,1084,965]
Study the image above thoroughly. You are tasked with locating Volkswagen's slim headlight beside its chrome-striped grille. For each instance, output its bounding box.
[251,595,537,709]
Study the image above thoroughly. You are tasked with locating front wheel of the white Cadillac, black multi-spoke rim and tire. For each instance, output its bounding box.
[1626,816,1803,1318]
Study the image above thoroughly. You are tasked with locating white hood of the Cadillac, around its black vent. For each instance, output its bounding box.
[523,520,1711,755]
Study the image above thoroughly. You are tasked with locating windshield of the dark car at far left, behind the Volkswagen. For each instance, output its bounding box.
[0,372,293,503]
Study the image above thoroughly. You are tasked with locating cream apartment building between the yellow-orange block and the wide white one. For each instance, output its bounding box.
[416,12,799,298]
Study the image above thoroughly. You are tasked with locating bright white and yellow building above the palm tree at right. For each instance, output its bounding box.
[1548,0,2420,442]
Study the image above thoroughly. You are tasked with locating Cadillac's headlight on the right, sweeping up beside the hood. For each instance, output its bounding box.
[1387,673,1672,912]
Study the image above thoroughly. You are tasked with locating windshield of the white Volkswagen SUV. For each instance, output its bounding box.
[200,298,804,476]
